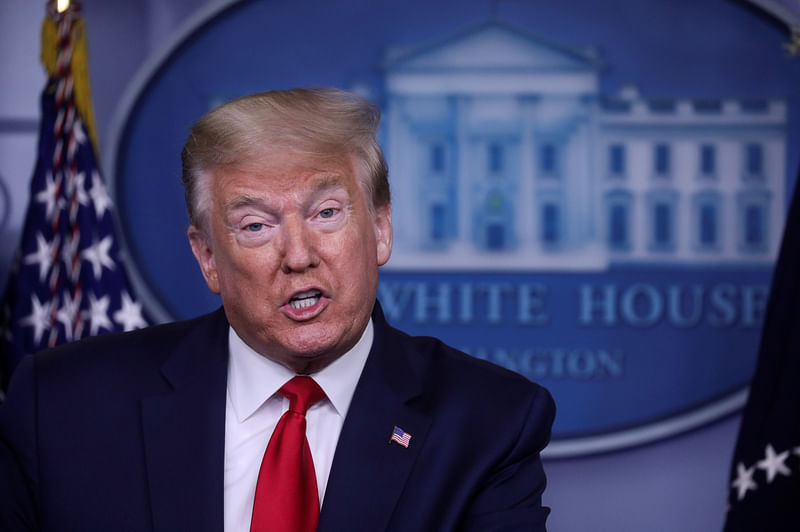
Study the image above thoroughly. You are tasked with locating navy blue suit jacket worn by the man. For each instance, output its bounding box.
[0,305,555,532]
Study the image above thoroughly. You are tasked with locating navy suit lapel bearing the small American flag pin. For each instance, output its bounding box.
[318,303,431,532]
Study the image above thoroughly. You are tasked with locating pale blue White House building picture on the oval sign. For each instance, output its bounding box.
[382,23,786,270]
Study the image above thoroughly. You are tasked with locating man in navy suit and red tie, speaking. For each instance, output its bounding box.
[0,89,554,532]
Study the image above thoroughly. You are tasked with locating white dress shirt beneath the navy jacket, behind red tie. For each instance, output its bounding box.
[224,320,373,532]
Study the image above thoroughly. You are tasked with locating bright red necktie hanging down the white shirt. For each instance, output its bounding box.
[250,377,325,532]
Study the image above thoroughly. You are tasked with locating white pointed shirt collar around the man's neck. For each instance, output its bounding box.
[228,319,374,423]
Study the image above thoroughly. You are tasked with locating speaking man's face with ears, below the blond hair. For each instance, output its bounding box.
[189,152,392,373]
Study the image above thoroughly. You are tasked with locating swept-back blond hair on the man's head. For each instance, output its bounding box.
[181,87,390,227]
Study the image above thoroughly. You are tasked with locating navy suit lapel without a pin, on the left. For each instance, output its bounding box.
[141,310,228,532]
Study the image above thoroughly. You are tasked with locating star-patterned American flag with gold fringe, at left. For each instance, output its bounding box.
[0,0,146,387]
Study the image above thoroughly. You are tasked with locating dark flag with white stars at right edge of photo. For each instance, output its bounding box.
[724,164,800,532]
